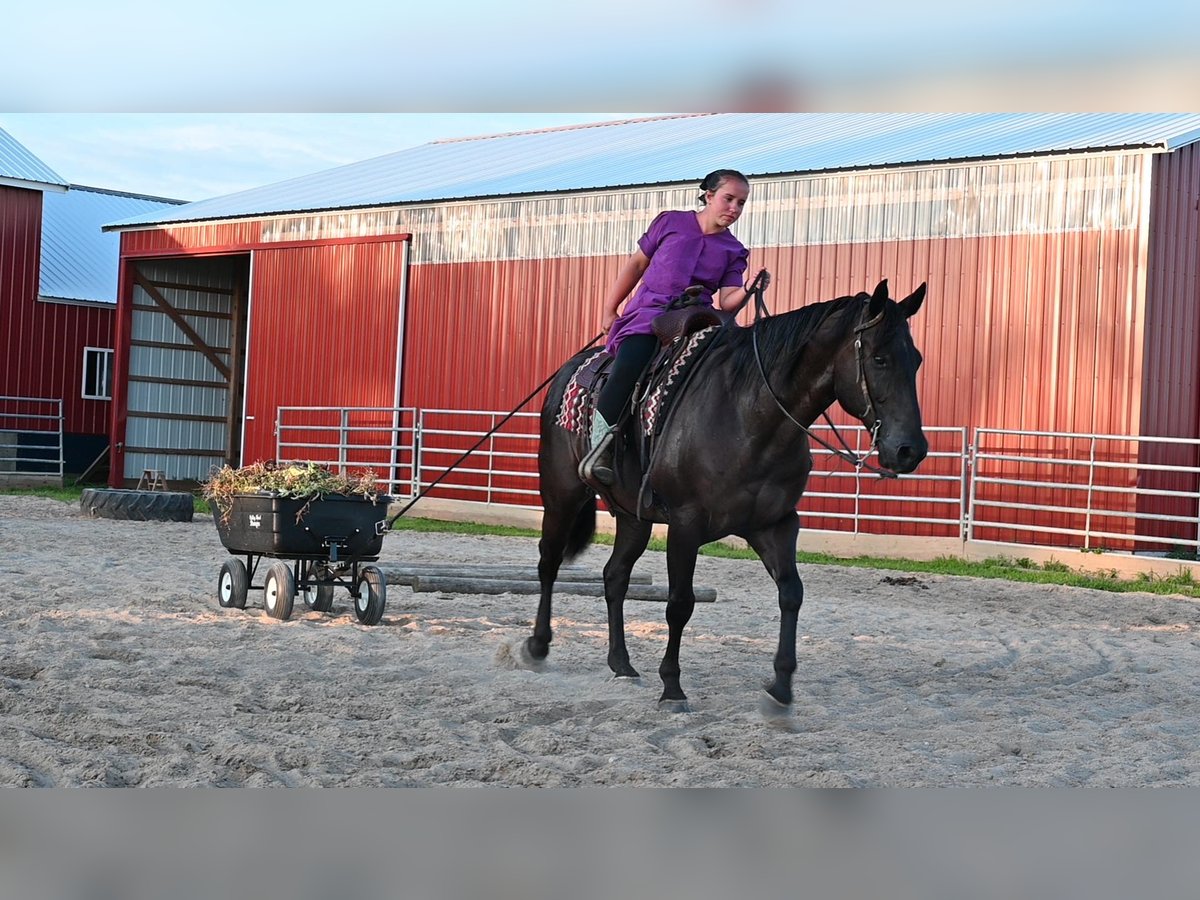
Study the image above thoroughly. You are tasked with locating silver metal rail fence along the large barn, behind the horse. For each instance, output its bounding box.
[276,407,1200,553]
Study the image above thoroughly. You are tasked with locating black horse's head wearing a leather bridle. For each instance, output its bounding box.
[834,278,929,474]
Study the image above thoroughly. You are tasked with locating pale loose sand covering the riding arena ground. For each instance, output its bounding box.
[0,497,1200,786]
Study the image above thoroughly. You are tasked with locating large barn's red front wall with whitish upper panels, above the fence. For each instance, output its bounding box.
[114,152,1152,536]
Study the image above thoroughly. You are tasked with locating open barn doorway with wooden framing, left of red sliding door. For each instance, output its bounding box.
[124,256,250,485]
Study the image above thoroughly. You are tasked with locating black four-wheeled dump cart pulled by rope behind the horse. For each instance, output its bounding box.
[212,493,391,625]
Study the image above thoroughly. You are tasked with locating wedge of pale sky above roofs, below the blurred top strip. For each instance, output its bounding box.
[0,113,652,200]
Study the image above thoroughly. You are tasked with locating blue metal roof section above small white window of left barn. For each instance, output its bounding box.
[37,185,180,304]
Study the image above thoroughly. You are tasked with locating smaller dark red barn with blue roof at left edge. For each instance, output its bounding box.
[0,130,178,480]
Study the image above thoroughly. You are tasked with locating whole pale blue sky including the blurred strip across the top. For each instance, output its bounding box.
[0,0,1200,199]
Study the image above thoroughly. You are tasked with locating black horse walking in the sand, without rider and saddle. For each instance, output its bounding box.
[518,281,929,713]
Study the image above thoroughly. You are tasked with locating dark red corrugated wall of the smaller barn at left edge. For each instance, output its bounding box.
[0,186,113,434]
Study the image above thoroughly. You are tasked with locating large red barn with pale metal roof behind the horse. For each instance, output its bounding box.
[100,114,1200,561]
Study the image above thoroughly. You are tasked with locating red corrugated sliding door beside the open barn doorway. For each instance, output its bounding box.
[244,240,410,463]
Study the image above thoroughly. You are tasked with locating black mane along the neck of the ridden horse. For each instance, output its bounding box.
[730,293,870,380]
